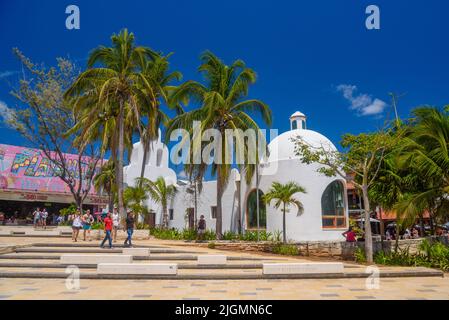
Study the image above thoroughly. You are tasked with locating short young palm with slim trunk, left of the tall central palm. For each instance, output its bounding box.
[136,177,177,228]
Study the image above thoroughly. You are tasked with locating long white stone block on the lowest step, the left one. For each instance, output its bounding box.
[97,263,178,275]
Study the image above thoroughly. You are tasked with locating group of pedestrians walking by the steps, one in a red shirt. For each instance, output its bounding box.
[69,208,135,249]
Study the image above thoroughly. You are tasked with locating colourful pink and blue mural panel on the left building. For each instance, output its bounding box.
[0,144,100,194]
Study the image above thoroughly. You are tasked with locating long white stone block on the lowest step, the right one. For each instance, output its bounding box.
[263,262,344,275]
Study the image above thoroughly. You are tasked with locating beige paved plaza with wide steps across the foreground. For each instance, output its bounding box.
[0,237,449,300]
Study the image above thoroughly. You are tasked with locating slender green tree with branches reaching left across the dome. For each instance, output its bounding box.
[293,132,395,263]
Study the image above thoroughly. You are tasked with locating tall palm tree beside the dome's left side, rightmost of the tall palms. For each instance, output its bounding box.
[167,52,271,239]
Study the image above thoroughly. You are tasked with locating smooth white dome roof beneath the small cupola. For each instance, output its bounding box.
[267,129,337,162]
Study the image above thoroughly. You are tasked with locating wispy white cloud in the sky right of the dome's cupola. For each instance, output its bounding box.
[337,84,387,116]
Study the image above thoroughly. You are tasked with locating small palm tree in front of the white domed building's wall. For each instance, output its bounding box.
[262,182,306,243]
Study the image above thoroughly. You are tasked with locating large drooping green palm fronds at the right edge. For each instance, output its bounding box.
[395,106,449,234]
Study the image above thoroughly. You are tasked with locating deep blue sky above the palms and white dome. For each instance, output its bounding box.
[0,0,449,156]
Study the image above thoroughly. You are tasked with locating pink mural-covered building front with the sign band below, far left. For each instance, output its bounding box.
[0,144,107,219]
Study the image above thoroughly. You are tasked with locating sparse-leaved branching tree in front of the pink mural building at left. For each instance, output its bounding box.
[7,49,102,210]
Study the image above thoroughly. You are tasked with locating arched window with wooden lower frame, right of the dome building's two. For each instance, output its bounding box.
[321,181,346,229]
